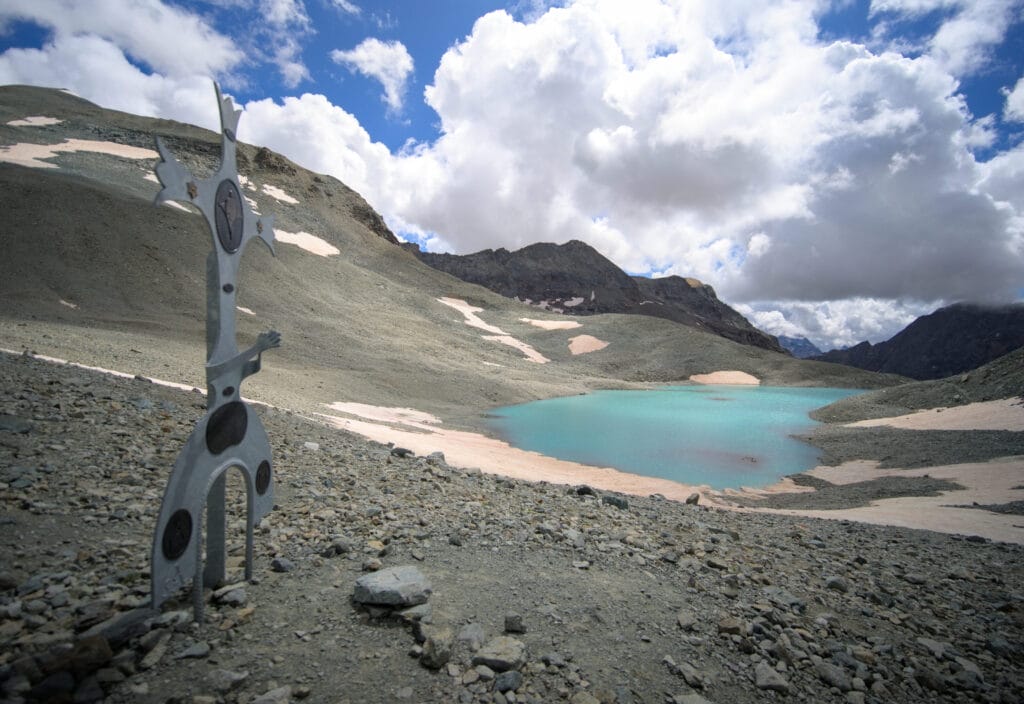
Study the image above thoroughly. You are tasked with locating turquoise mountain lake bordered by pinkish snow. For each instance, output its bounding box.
[487,386,860,489]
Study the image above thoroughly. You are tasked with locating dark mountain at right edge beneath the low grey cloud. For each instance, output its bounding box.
[814,303,1024,380]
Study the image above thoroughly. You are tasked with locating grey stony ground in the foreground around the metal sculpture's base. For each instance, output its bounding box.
[0,355,1024,704]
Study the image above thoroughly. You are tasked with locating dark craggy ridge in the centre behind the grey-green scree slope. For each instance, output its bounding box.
[404,240,783,352]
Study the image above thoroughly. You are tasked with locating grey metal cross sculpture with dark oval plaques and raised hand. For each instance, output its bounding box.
[151,83,281,621]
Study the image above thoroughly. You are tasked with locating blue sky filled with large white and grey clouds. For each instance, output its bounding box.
[0,0,1024,347]
